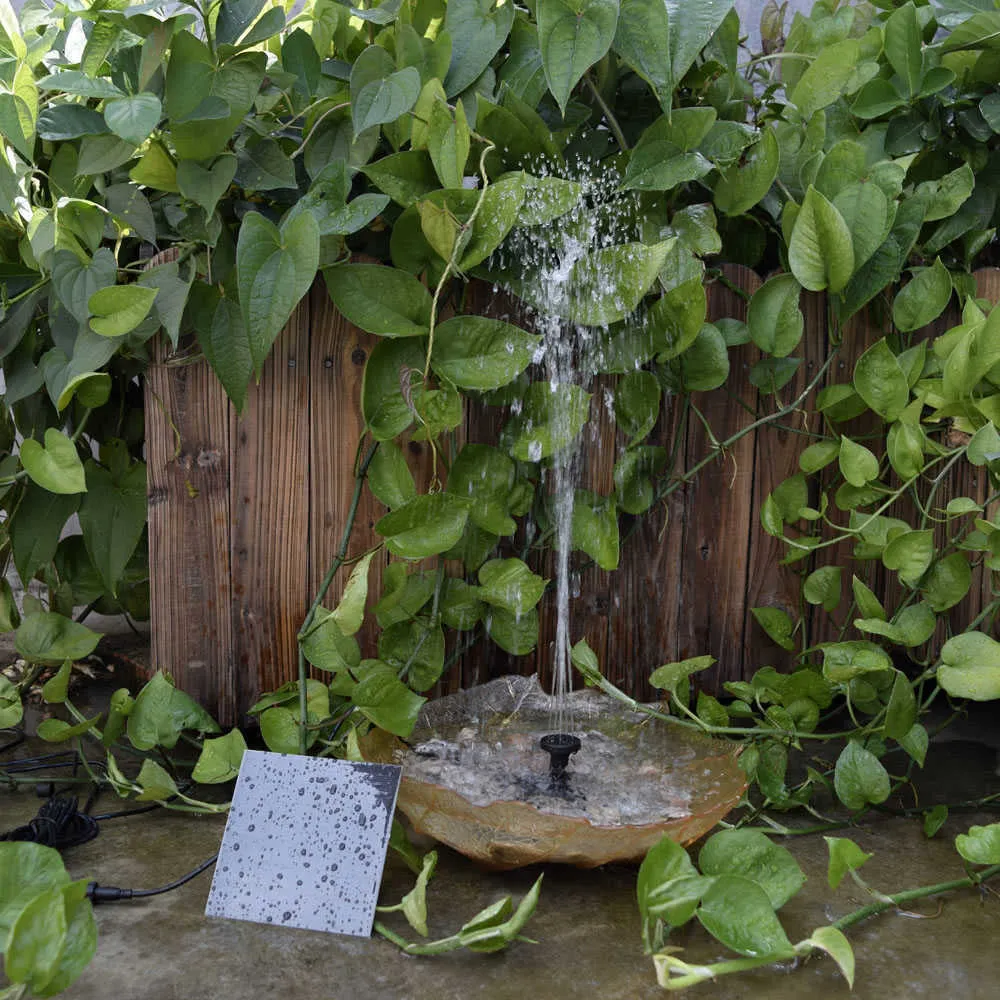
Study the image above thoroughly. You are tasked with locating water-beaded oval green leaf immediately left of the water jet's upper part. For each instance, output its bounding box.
[431,316,541,391]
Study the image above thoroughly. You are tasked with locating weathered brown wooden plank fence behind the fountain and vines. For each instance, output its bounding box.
[146,268,1000,723]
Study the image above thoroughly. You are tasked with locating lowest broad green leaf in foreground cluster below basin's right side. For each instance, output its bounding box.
[696,875,795,961]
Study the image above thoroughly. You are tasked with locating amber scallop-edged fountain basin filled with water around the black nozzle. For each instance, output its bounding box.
[362,676,747,870]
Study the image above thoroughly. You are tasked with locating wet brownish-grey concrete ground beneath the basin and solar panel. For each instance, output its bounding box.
[0,688,1000,1000]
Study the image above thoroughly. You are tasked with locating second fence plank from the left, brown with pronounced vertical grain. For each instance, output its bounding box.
[230,301,310,706]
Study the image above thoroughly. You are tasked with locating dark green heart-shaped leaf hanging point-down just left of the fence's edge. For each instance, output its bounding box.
[80,460,147,595]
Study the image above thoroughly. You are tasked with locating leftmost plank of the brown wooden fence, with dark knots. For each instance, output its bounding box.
[145,338,238,721]
